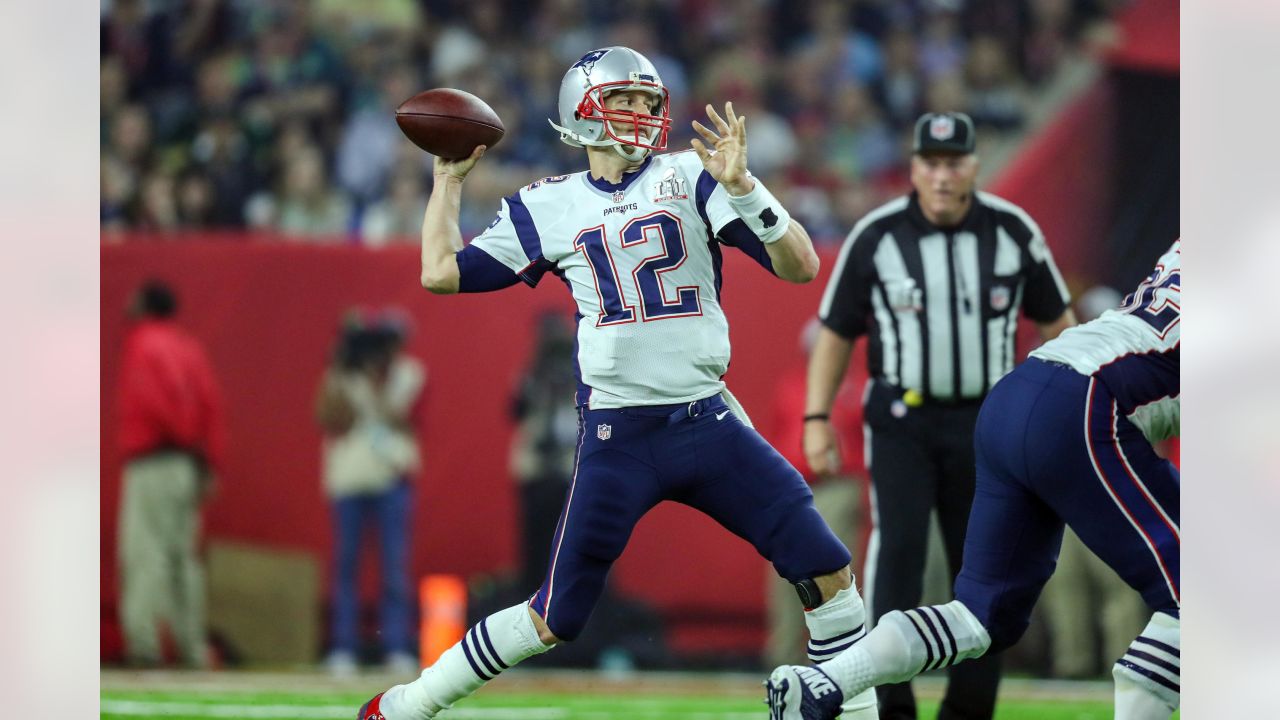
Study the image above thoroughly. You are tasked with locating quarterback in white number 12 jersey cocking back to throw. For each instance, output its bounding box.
[357,47,877,720]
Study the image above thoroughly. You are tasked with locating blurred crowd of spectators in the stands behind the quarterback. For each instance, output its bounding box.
[101,0,1124,246]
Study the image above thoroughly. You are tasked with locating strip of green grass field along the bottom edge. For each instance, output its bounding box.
[101,671,1172,720]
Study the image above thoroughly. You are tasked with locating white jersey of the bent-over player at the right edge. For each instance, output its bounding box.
[1030,241,1183,442]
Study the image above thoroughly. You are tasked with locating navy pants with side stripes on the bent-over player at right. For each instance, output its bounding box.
[955,357,1180,652]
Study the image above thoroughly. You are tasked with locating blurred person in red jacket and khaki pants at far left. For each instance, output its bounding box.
[116,281,225,667]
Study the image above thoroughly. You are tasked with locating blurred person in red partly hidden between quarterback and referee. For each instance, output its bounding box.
[762,319,869,667]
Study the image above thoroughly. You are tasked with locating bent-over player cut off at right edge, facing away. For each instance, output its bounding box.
[768,241,1181,720]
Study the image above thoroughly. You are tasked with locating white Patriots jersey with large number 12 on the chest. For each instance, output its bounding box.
[472,151,754,409]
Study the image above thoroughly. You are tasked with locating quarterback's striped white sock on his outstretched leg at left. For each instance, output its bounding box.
[381,602,556,720]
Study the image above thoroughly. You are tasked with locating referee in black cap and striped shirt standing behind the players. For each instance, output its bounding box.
[804,113,1075,720]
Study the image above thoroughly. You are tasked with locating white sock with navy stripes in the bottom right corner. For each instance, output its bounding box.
[1111,612,1181,720]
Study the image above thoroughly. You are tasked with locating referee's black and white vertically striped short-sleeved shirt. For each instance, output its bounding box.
[818,192,1070,402]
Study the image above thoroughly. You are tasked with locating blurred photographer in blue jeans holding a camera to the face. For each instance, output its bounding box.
[316,303,426,675]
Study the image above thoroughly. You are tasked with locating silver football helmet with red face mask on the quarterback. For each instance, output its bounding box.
[547,47,671,161]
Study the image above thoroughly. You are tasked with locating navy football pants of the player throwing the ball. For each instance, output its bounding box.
[531,395,850,641]
